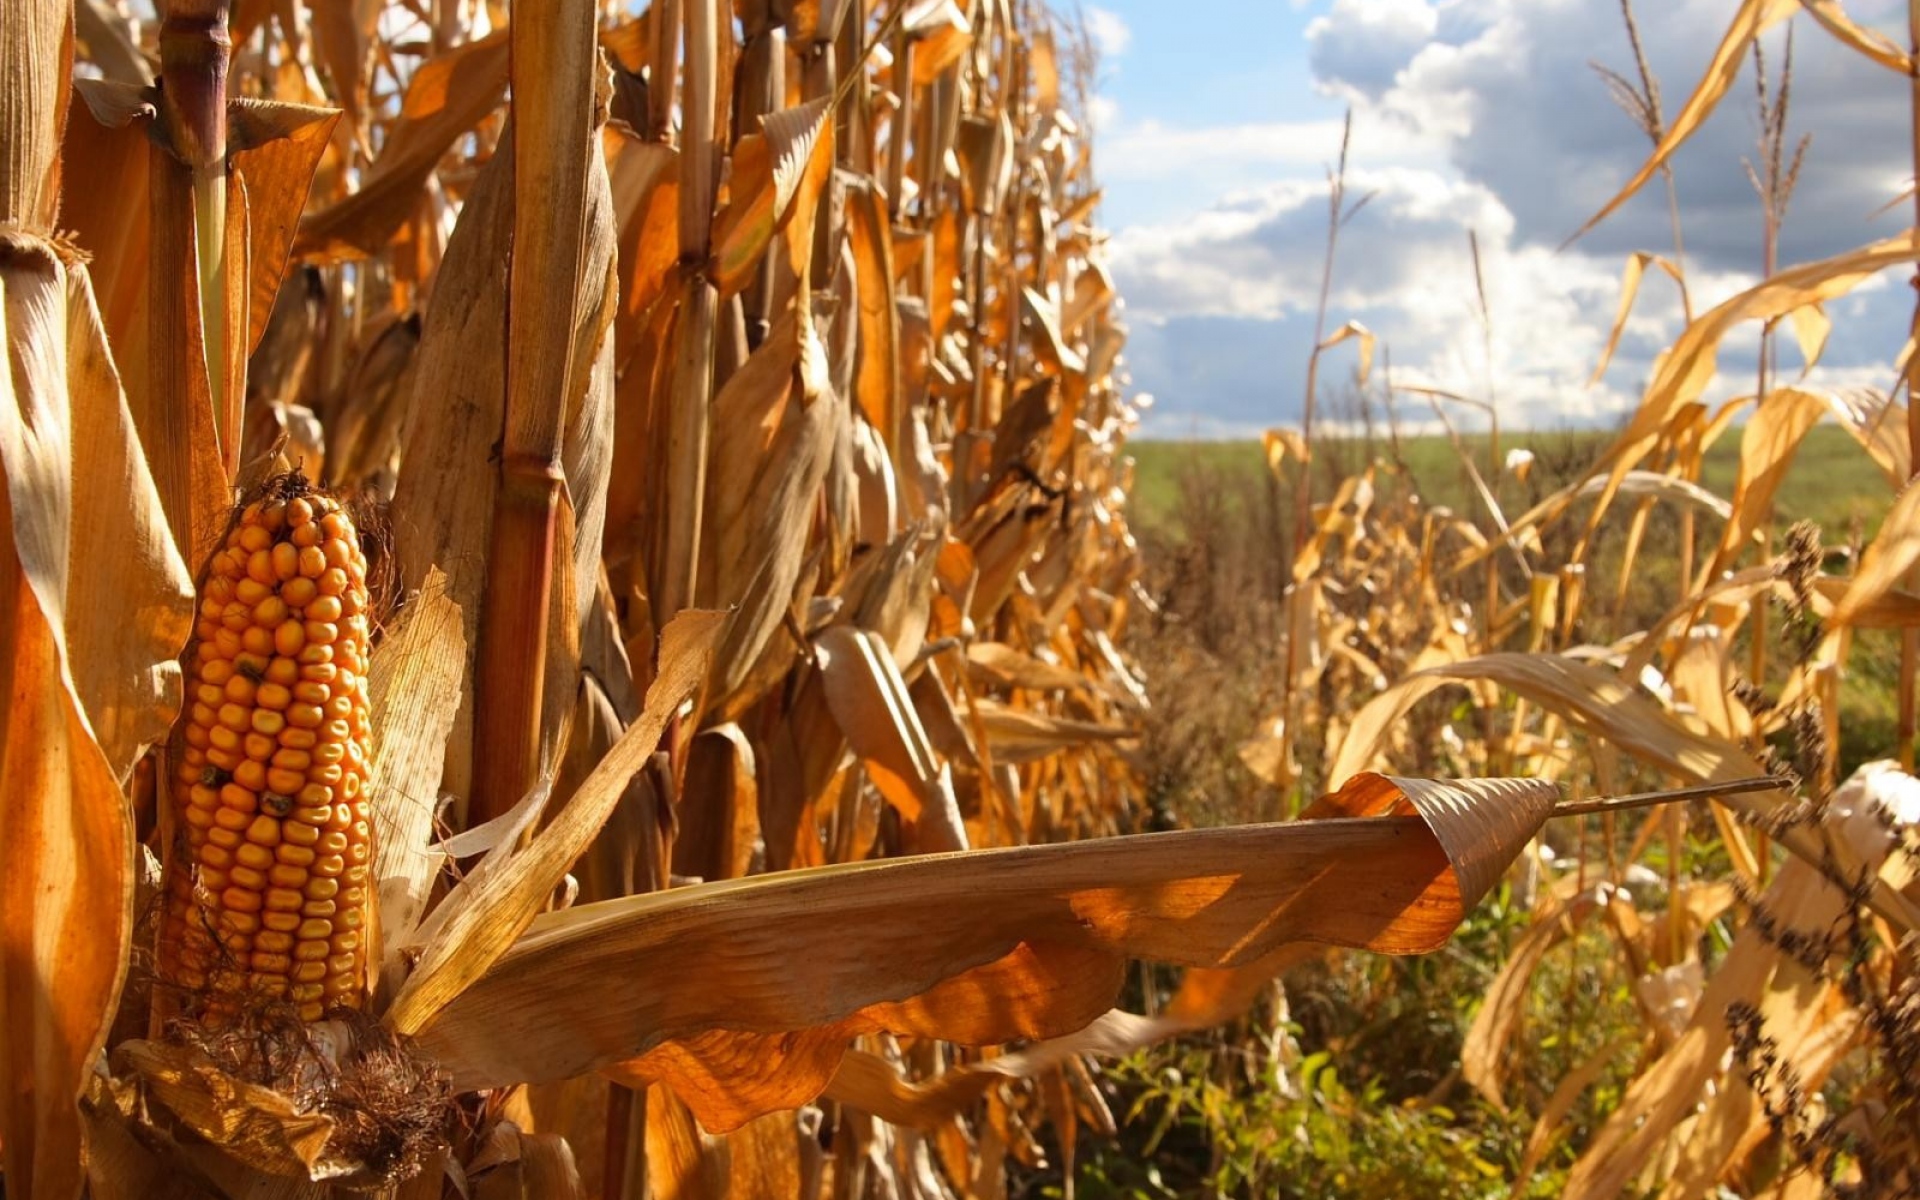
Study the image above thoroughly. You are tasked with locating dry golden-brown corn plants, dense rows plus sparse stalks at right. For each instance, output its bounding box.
[0,0,1920,1200]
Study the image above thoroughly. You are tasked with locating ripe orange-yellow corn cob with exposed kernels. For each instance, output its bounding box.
[159,472,372,1021]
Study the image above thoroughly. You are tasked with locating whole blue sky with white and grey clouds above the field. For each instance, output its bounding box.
[1082,0,1912,436]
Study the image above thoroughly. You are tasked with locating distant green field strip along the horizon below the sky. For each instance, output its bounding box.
[1127,424,1891,543]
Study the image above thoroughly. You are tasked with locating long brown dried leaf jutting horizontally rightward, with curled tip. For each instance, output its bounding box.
[420,776,1557,1121]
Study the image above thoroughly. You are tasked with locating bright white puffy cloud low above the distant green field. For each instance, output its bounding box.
[1114,169,1676,434]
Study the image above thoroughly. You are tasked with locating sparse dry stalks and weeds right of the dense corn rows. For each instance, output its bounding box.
[1121,0,1920,1198]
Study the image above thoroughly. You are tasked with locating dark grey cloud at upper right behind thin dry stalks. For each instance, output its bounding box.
[1311,0,1912,269]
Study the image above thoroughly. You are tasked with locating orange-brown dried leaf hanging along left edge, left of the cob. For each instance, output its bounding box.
[0,239,163,1196]
